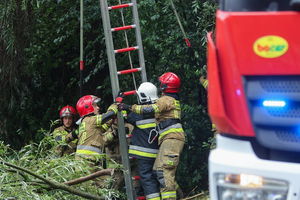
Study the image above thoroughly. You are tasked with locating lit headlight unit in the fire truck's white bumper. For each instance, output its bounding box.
[215,173,288,200]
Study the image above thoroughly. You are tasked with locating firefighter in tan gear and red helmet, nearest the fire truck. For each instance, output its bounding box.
[118,72,185,199]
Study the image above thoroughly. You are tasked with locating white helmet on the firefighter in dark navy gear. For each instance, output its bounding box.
[136,82,158,103]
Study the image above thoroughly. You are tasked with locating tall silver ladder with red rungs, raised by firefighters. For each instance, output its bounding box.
[100,0,147,200]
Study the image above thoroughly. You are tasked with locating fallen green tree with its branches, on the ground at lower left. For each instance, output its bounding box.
[0,135,126,200]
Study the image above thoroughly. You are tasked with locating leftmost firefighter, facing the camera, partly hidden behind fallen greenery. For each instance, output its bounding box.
[52,105,78,156]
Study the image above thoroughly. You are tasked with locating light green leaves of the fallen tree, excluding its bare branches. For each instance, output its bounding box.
[0,130,123,200]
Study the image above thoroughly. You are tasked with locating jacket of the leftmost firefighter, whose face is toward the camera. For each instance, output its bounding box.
[52,126,78,156]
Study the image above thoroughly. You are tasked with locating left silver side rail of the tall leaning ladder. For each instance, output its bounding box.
[100,0,135,200]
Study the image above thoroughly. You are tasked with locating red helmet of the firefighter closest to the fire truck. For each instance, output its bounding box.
[159,72,181,93]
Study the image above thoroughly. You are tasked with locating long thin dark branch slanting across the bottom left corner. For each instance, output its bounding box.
[0,160,105,200]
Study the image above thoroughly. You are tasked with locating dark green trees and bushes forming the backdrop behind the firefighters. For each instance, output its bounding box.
[0,0,216,199]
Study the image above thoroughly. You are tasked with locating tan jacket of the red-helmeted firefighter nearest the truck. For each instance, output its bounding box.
[131,93,184,144]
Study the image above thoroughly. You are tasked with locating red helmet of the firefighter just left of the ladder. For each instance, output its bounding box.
[76,95,100,117]
